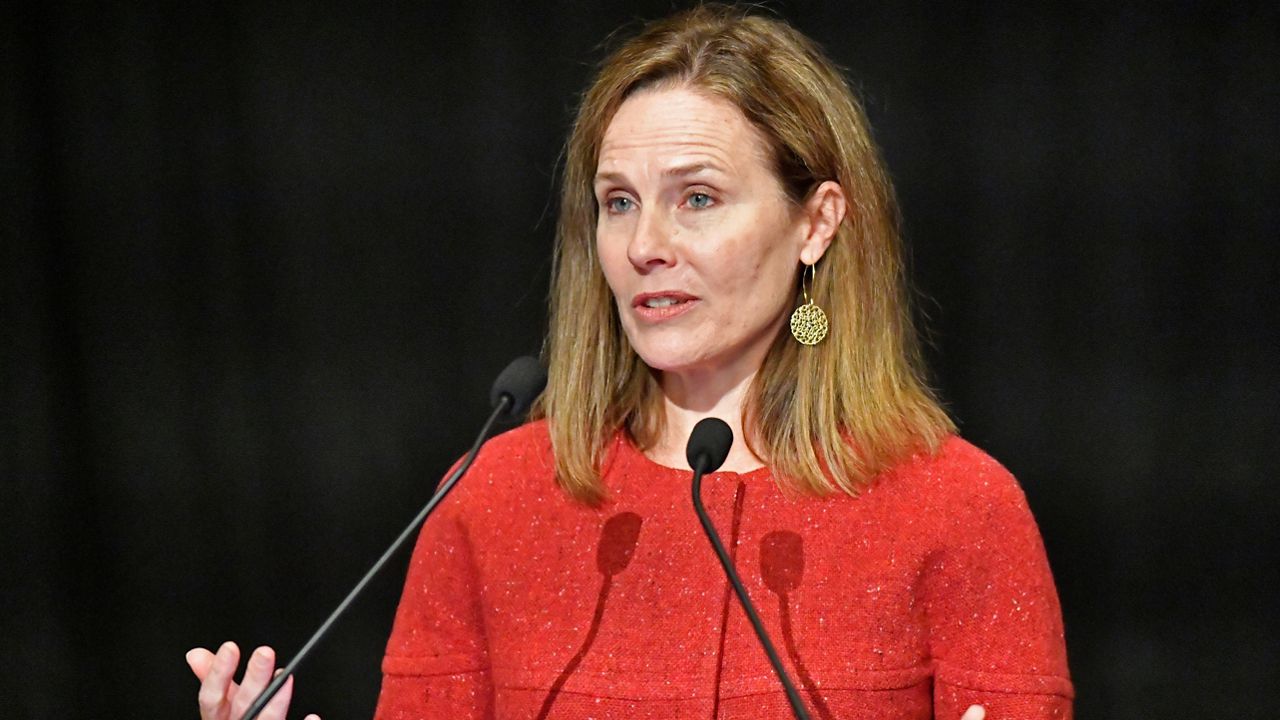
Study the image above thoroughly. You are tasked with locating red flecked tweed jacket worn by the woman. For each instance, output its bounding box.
[376,423,1073,720]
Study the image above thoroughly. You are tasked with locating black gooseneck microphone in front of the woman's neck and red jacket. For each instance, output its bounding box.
[685,418,809,720]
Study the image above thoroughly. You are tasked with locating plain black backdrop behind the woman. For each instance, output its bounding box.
[0,1,1280,719]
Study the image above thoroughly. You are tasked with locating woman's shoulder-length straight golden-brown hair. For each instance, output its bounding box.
[524,6,954,502]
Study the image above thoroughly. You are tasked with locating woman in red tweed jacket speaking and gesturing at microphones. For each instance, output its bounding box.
[189,8,1073,720]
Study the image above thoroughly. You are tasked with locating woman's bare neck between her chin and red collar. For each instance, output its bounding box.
[648,363,764,473]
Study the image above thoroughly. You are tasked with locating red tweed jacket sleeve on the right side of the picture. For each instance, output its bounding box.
[924,451,1074,720]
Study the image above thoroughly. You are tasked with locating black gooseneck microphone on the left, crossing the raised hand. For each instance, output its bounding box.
[241,355,545,720]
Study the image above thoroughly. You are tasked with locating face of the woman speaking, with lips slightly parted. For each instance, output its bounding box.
[595,87,826,381]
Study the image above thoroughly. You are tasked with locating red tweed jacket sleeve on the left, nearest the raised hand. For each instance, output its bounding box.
[374,493,493,720]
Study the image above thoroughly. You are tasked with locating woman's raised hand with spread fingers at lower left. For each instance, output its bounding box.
[187,642,320,720]
